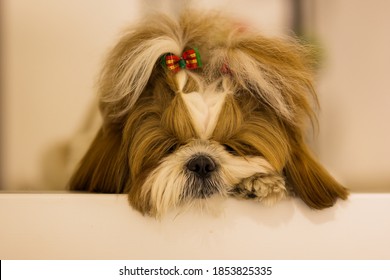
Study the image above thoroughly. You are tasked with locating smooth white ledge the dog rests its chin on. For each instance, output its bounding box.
[0,193,390,259]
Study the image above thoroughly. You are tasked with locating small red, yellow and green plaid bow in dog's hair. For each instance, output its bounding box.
[161,48,202,73]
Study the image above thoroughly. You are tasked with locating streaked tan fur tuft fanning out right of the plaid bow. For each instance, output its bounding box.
[210,30,318,126]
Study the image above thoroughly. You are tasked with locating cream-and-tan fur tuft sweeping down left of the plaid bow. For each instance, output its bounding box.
[98,16,182,125]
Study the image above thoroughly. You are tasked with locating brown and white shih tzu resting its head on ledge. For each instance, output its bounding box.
[70,11,348,217]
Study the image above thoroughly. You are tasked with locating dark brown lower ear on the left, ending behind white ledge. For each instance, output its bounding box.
[69,129,129,193]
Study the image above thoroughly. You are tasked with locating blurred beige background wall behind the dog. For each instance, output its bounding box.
[0,0,390,192]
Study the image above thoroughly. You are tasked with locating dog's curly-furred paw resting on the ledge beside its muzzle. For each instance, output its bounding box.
[231,173,287,205]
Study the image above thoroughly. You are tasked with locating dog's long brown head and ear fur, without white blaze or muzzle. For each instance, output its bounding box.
[70,8,348,213]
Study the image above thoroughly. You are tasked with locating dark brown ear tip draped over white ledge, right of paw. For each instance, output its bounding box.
[284,136,348,209]
